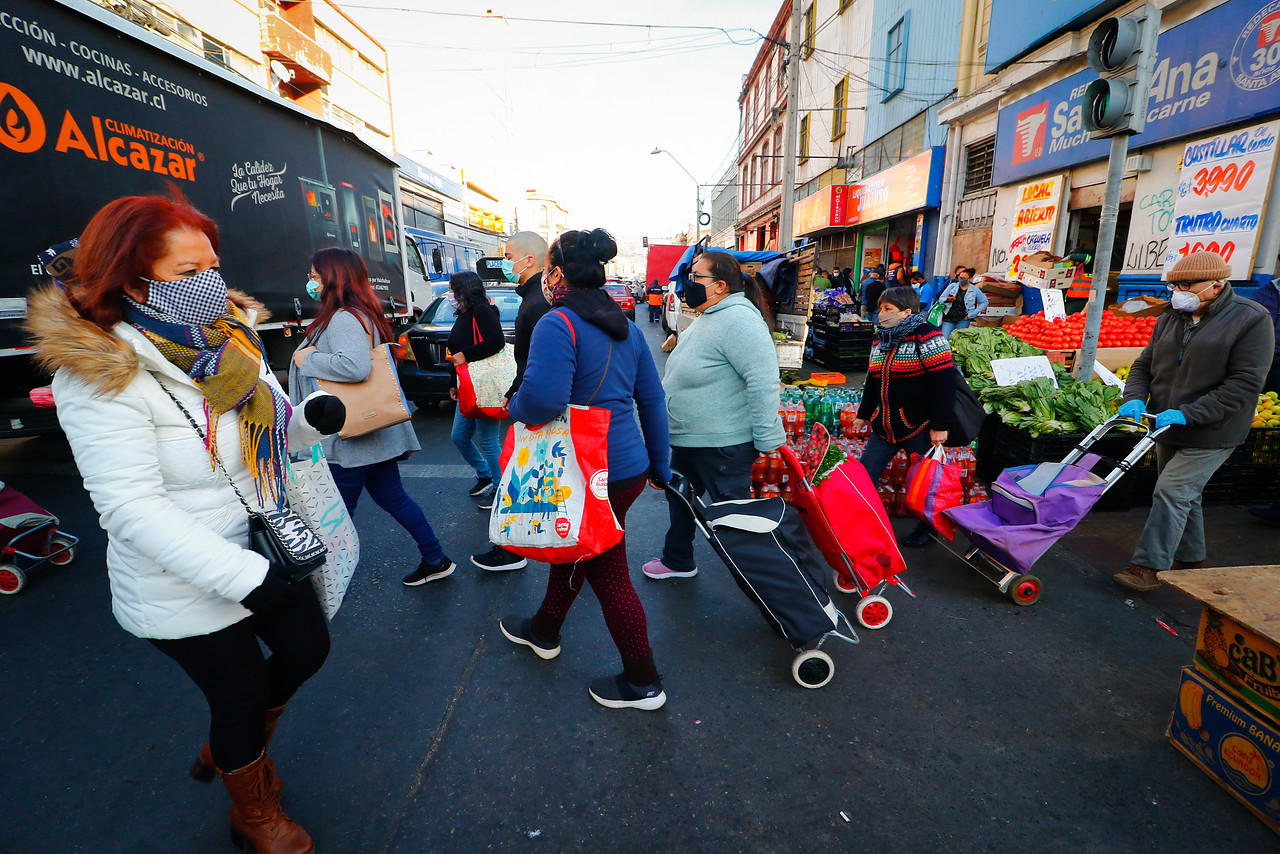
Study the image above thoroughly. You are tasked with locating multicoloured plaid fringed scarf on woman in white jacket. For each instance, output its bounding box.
[124,298,289,507]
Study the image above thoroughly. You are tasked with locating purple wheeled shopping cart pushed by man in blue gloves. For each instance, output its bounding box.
[943,412,1165,606]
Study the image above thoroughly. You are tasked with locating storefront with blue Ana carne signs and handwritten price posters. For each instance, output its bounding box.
[942,0,1280,287]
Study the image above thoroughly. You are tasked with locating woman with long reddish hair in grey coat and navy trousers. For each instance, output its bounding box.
[289,247,457,586]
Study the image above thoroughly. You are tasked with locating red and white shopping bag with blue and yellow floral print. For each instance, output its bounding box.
[489,406,622,563]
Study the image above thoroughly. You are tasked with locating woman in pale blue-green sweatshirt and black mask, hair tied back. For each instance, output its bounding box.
[644,252,786,580]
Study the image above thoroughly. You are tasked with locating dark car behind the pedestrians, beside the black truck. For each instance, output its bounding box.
[397,286,520,406]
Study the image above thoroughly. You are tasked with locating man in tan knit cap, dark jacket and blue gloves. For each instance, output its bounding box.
[1115,252,1275,590]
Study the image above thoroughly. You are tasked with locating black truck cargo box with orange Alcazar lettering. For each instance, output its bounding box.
[0,0,409,438]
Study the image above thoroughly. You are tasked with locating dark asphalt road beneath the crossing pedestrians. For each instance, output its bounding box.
[0,320,1277,854]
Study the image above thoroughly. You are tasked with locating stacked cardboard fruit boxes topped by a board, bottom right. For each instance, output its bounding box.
[1160,566,1280,832]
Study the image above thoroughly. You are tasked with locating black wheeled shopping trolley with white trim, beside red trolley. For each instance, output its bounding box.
[667,472,858,688]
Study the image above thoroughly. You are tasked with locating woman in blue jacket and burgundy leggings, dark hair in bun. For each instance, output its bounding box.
[499,228,671,711]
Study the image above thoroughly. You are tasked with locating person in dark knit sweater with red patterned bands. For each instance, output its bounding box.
[855,287,955,545]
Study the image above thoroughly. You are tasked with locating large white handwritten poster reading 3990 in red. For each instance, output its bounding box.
[1165,123,1280,279]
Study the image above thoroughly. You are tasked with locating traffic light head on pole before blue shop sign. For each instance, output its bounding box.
[1083,3,1160,140]
